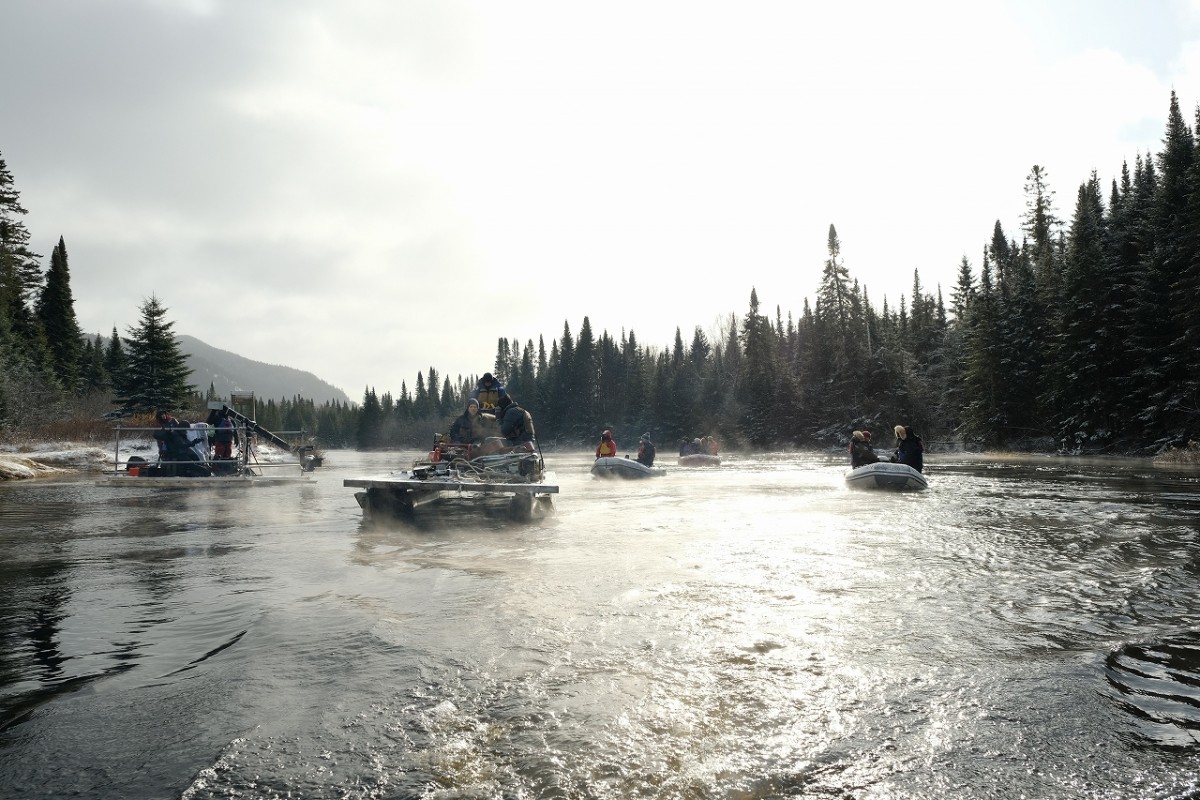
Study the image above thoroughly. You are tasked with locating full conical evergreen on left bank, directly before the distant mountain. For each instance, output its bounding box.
[116,295,196,413]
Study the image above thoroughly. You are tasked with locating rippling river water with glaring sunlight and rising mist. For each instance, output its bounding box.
[0,451,1200,800]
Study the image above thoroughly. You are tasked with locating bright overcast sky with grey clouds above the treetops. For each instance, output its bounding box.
[0,0,1200,401]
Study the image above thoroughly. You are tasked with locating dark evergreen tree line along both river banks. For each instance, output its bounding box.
[0,92,1200,452]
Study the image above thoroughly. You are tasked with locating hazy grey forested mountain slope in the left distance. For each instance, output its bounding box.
[175,336,350,405]
